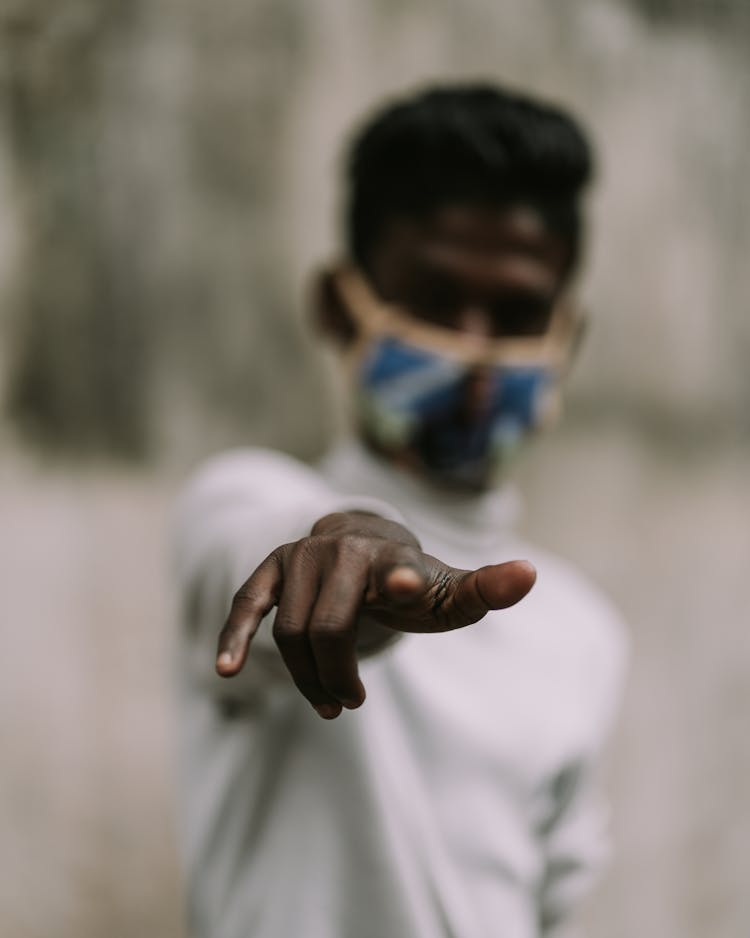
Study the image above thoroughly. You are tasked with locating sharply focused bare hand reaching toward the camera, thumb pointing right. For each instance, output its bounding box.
[216,512,536,719]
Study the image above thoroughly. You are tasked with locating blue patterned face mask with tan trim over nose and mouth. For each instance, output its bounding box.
[336,268,575,489]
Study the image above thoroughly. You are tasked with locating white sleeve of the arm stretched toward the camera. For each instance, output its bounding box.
[173,449,402,703]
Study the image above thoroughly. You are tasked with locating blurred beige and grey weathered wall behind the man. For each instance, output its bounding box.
[0,0,750,938]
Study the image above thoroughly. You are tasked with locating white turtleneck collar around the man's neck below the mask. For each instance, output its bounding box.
[319,439,521,548]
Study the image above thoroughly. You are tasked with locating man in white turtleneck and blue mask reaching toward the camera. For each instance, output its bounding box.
[178,86,623,938]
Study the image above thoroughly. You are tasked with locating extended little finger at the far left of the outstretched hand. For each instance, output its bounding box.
[216,551,282,677]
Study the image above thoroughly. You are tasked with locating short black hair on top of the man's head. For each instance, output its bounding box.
[346,84,593,267]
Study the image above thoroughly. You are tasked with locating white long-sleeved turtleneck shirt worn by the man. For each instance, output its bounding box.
[172,445,625,938]
